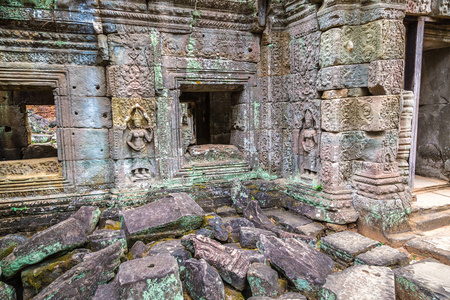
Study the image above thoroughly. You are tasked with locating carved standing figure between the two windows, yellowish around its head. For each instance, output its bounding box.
[127,108,153,181]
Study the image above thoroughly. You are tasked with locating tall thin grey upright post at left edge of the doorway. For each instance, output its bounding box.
[405,17,425,189]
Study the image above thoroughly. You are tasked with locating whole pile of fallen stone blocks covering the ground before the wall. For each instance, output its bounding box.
[0,193,450,300]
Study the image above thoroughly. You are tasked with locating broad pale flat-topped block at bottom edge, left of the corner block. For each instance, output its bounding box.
[319,265,395,300]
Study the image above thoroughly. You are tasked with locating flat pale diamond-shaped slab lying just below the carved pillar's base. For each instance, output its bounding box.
[320,231,380,268]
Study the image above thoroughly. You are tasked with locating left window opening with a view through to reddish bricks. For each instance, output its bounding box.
[0,89,57,161]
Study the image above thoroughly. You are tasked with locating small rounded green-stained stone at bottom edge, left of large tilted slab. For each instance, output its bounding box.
[247,263,281,297]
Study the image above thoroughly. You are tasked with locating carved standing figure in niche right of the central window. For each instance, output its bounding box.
[300,109,319,174]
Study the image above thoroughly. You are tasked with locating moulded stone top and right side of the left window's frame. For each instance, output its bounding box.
[0,63,75,187]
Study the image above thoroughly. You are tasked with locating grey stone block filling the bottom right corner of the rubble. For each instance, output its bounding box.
[394,258,450,300]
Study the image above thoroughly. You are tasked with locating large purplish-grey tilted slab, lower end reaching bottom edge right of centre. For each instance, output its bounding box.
[258,235,334,298]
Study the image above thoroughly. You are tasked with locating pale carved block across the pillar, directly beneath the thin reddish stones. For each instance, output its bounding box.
[322,96,400,132]
